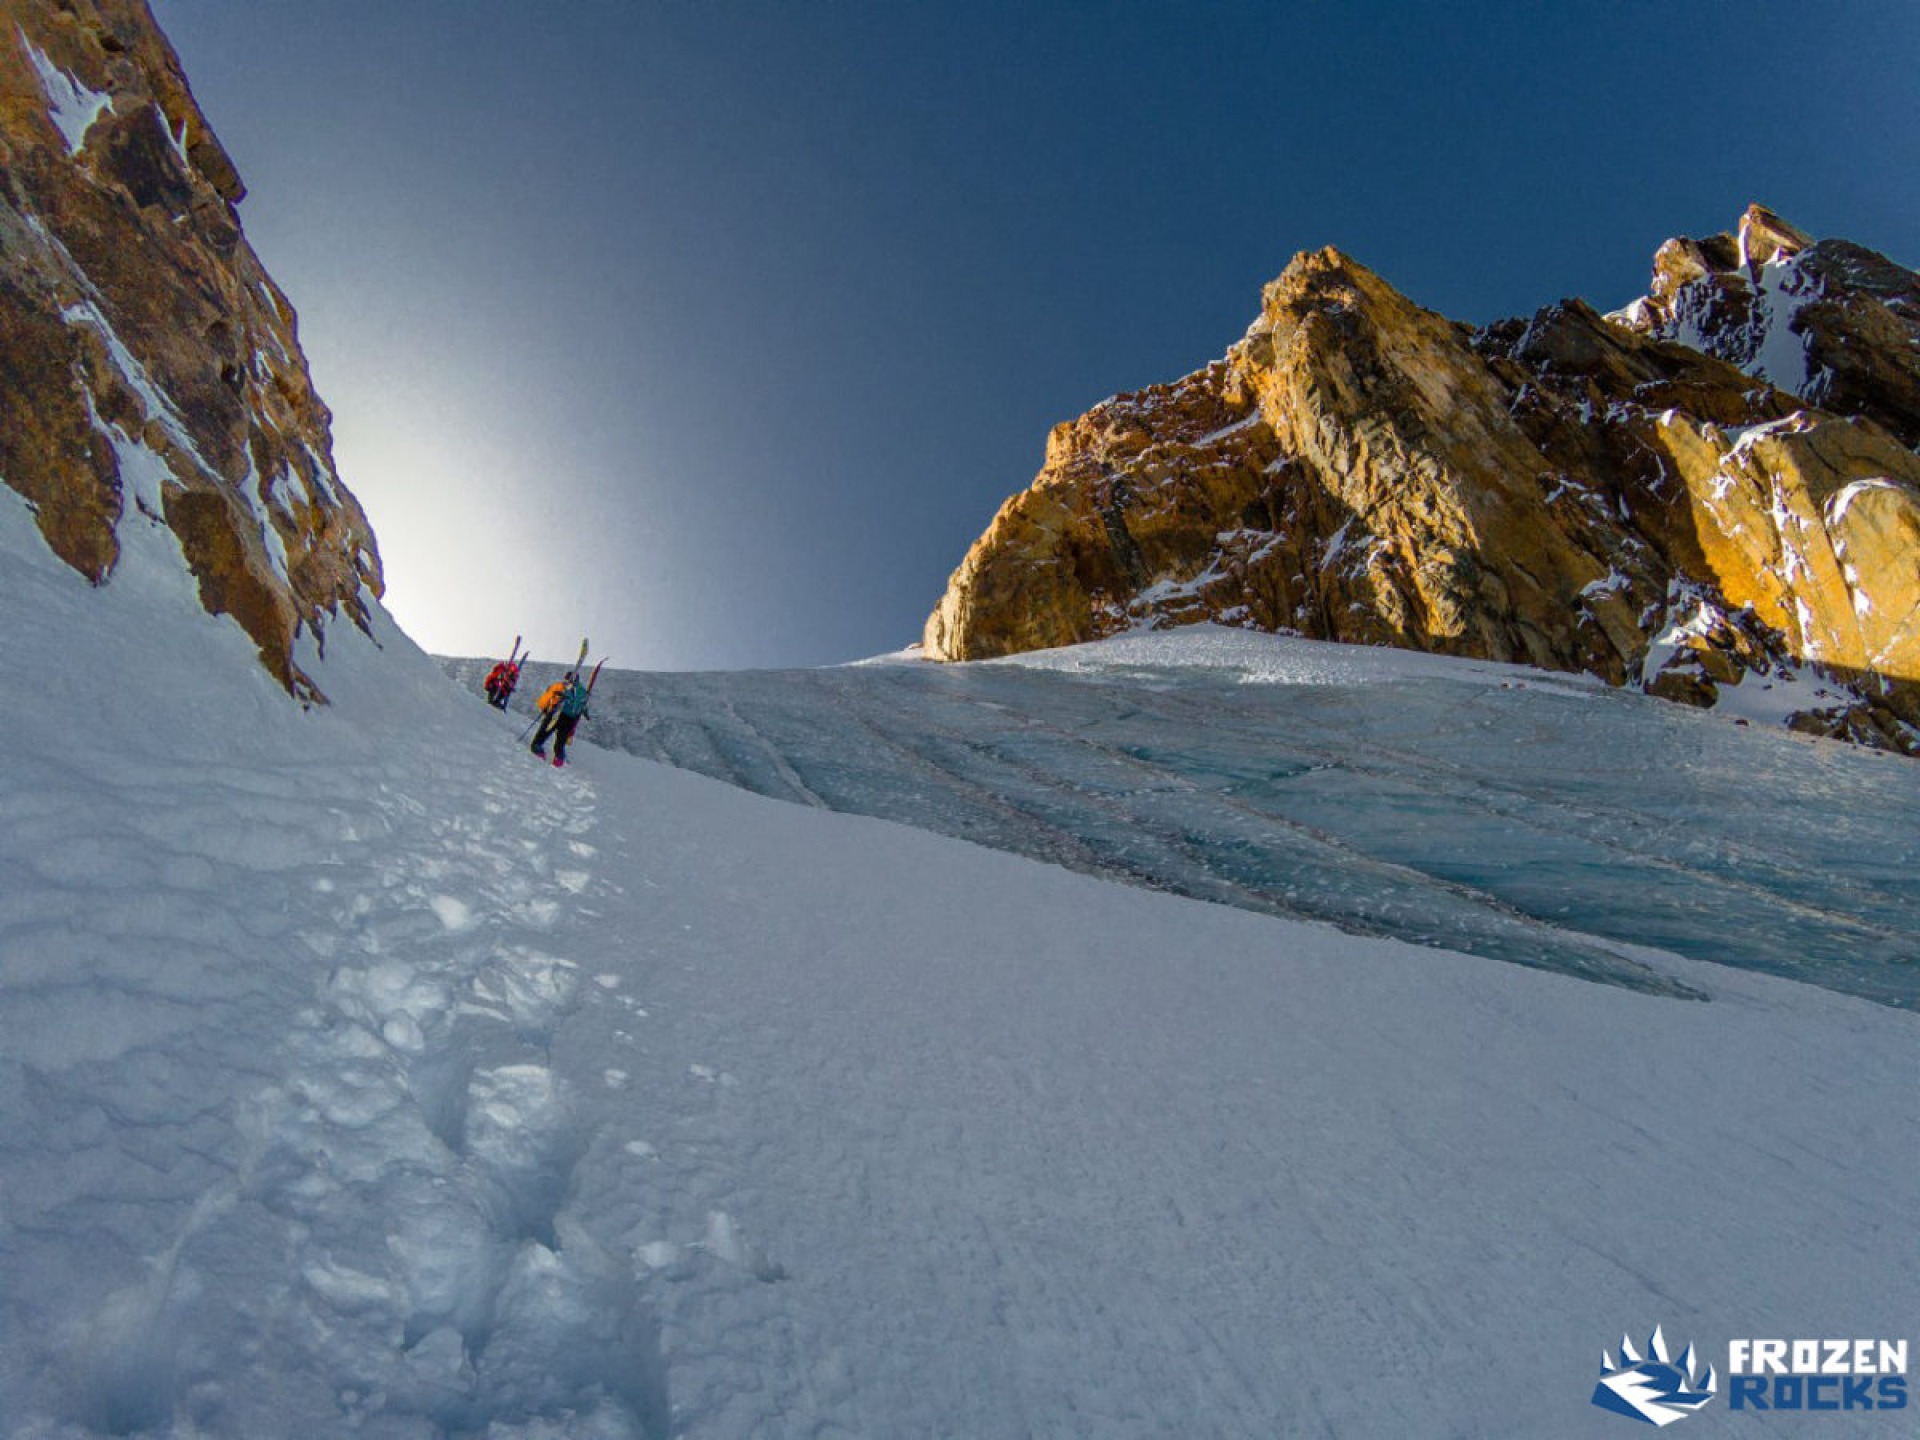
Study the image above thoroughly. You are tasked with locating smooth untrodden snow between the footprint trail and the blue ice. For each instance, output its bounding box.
[563,756,1916,1436]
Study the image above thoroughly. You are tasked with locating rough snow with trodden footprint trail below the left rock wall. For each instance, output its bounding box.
[0,497,666,1436]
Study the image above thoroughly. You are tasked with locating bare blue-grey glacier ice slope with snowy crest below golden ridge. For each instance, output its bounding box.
[480,626,1920,1006]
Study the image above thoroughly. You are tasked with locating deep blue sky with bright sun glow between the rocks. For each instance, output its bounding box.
[152,0,1920,668]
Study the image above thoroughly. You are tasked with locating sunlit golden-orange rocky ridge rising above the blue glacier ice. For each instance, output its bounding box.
[925,207,1920,749]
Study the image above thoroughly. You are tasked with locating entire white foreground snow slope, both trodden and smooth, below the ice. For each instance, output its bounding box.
[0,503,1920,1440]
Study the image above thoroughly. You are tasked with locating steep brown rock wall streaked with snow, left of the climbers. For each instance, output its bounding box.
[0,0,380,699]
